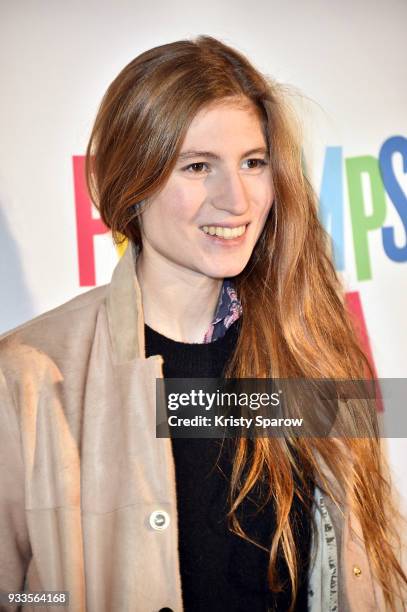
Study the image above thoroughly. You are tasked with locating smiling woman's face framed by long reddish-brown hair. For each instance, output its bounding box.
[141,102,274,279]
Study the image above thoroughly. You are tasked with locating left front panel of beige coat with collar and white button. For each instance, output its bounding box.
[81,244,182,612]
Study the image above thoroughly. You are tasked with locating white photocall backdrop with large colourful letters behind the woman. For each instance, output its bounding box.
[0,0,407,524]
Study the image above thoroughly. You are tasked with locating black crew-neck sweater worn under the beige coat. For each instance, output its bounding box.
[145,319,310,612]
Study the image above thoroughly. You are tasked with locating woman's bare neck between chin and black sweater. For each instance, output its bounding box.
[136,247,223,342]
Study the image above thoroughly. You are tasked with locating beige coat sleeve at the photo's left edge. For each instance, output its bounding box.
[0,369,31,612]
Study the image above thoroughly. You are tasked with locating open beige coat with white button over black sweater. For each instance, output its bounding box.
[0,241,384,612]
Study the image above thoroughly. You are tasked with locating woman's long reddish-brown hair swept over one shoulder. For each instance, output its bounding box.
[86,36,407,608]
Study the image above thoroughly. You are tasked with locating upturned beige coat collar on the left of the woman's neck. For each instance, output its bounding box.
[106,241,145,364]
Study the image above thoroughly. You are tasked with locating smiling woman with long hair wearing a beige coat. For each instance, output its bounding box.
[0,36,406,612]
